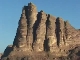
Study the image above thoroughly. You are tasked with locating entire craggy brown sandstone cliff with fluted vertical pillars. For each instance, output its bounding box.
[2,3,80,60]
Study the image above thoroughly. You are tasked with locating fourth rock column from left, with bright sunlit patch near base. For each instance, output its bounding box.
[46,15,57,52]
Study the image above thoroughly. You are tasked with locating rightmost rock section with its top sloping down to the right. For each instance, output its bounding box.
[65,21,80,45]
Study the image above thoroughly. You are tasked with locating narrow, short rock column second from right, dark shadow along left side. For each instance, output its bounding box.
[56,17,65,47]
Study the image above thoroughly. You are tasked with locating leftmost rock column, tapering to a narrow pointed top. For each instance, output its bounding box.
[13,9,27,51]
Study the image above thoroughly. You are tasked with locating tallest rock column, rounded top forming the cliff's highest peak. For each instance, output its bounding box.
[26,3,37,50]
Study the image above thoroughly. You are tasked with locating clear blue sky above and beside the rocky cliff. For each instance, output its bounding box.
[0,0,80,52]
